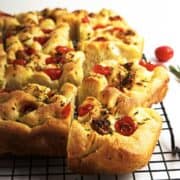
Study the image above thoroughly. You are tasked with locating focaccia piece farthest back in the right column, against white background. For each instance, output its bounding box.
[78,9,144,71]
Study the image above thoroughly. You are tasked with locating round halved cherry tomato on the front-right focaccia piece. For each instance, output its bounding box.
[114,116,137,136]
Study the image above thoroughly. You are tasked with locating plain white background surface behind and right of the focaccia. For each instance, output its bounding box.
[0,0,180,146]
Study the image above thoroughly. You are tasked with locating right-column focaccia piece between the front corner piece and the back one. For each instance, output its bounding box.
[78,60,169,113]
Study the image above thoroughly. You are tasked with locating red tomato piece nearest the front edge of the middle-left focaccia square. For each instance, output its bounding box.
[43,68,62,80]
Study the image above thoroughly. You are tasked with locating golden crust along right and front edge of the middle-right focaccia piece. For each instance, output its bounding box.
[112,67,169,113]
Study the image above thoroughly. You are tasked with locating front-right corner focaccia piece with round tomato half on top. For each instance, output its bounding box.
[67,97,162,174]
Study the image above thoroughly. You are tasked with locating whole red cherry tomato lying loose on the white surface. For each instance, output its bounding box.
[155,46,174,62]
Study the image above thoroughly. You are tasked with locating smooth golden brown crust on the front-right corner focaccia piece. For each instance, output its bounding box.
[67,109,162,174]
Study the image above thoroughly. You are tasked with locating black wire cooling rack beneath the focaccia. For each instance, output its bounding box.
[0,103,180,180]
